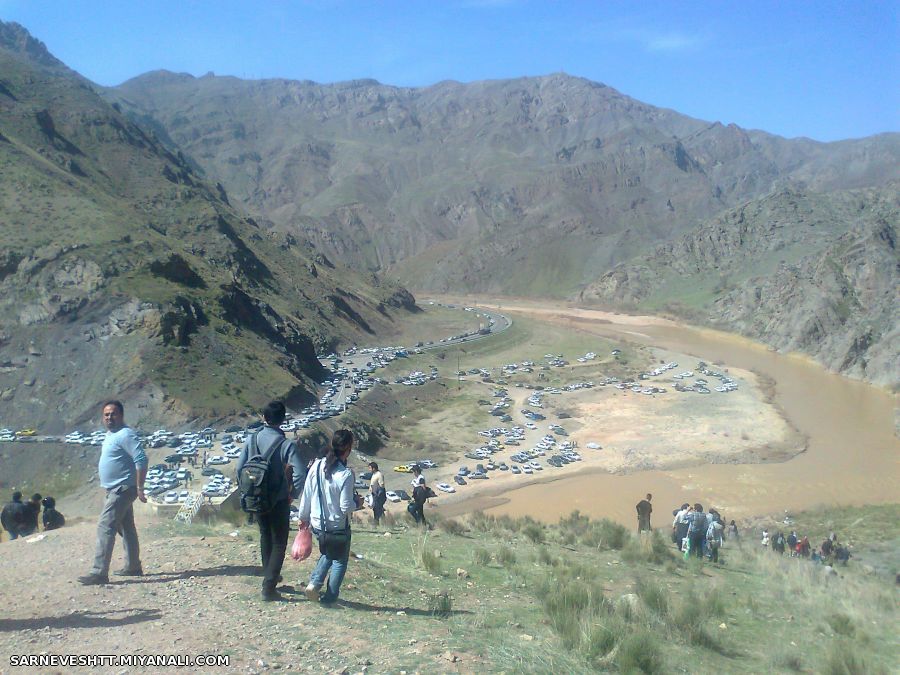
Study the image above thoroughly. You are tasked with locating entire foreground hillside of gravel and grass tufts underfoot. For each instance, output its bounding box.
[0,506,898,673]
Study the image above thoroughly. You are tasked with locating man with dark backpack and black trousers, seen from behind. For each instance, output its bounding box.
[237,401,306,602]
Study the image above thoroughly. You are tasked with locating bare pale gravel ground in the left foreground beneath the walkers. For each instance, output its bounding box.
[0,519,475,673]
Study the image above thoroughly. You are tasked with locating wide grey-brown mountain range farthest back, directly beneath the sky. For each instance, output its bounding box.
[108,71,900,296]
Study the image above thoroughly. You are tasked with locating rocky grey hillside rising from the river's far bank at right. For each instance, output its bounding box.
[581,183,900,387]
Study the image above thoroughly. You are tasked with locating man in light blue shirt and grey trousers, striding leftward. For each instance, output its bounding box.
[78,401,147,586]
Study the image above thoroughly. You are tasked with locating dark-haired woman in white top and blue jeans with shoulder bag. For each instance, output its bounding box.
[300,429,362,605]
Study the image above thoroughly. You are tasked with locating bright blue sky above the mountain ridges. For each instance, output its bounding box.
[0,0,900,141]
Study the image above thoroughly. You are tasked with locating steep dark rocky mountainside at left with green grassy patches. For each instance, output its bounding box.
[0,23,416,430]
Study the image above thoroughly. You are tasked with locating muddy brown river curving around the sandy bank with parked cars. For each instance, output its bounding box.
[446,301,900,526]
